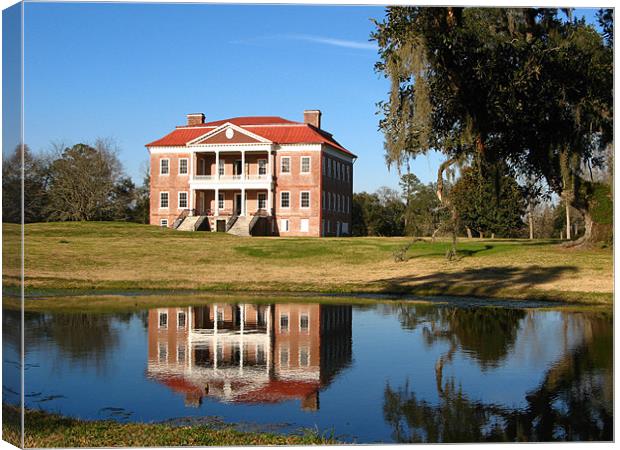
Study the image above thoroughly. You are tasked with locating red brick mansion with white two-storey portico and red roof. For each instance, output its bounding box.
[146,110,356,237]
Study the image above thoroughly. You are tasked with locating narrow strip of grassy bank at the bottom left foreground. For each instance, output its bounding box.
[2,405,337,448]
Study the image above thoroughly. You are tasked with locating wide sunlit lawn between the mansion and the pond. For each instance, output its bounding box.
[3,223,613,303]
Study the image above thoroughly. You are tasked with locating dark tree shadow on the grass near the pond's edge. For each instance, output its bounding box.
[373,265,579,297]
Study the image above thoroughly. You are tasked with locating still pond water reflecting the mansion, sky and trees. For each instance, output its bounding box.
[3,303,613,443]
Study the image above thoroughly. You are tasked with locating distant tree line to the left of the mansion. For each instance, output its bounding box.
[2,139,149,223]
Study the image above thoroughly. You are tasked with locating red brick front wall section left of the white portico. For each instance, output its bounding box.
[150,153,191,227]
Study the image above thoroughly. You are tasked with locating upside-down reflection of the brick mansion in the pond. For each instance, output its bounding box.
[147,304,351,410]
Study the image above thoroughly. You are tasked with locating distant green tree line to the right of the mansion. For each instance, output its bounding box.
[352,166,596,239]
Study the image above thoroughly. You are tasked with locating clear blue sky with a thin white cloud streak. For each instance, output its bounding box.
[17,3,594,192]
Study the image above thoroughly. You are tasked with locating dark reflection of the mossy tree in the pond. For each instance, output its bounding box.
[383,307,613,442]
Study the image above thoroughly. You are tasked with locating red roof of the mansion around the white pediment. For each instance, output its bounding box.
[146,116,353,155]
